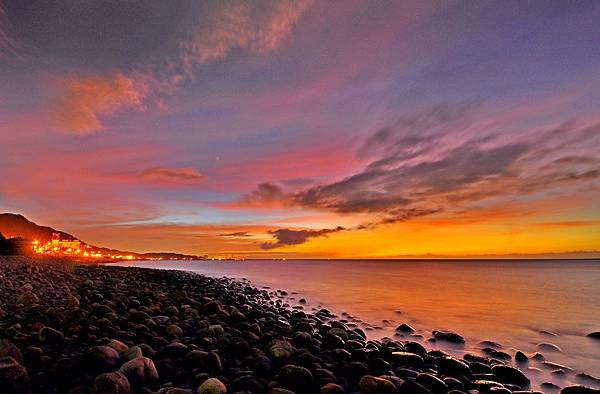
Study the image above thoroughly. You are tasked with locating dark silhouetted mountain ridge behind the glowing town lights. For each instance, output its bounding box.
[0,213,201,259]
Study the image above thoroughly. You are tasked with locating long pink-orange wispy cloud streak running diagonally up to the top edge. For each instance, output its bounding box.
[40,0,312,134]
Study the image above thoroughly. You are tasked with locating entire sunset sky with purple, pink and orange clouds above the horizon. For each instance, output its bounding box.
[0,0,600,258]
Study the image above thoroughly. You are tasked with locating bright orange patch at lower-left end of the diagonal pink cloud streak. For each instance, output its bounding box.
[55,73,143,134]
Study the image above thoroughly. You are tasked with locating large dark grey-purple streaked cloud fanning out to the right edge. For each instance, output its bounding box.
[241,103,600,228]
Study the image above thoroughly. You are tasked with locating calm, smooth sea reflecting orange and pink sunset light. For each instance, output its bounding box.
[113,260,600,387]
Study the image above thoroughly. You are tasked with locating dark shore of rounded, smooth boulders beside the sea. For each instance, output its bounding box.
[0,258,600,394]
